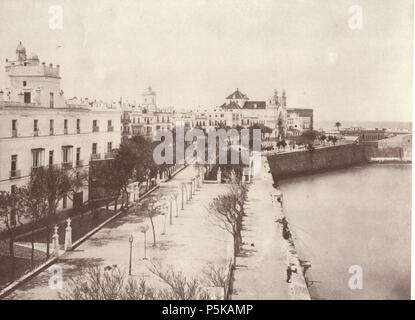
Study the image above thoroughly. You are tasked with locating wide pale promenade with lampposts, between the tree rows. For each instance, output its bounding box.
[7,166,232,299]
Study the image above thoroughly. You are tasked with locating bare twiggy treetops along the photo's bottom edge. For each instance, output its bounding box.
[60,262,227,300]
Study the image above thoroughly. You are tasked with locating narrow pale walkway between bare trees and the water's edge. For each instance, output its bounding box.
[232,174,291,300]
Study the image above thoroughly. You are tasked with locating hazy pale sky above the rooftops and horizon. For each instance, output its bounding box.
[0,0,413,121]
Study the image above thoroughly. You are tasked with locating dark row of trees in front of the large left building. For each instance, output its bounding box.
[0,136,177,280]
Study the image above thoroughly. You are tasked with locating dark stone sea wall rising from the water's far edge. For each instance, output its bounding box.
[268,144,369,181]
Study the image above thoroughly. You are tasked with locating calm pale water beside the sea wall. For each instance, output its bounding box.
[280,164,411,299]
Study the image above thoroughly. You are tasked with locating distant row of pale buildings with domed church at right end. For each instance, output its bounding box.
[123,87,313,138]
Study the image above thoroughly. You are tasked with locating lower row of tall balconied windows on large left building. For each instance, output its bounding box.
[10,142,113,178]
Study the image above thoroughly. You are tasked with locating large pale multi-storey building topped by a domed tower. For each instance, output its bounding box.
[0,43,121,209]
